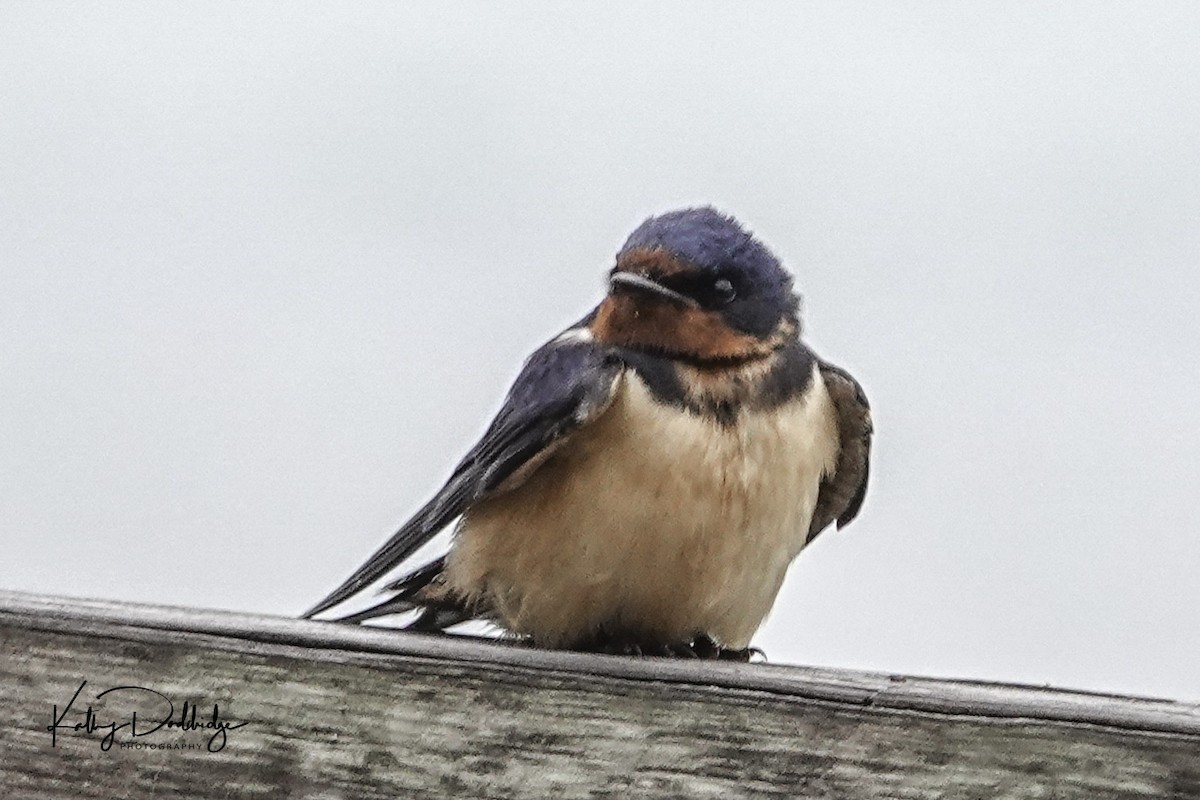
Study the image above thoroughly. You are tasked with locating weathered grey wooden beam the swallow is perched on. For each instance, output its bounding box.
[0,593,1200,800]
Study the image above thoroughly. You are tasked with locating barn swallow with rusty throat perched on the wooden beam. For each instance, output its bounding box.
[305,207,872,657]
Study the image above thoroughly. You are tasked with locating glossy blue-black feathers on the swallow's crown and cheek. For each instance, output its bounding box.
[617,206,799,337]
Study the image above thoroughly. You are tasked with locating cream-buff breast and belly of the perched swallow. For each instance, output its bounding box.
[448,369,838,648]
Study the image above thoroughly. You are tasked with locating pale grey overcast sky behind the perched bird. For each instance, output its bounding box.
[0,1,1200,699]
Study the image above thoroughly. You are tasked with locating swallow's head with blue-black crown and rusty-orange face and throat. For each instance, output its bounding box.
[592,207,799,366]
